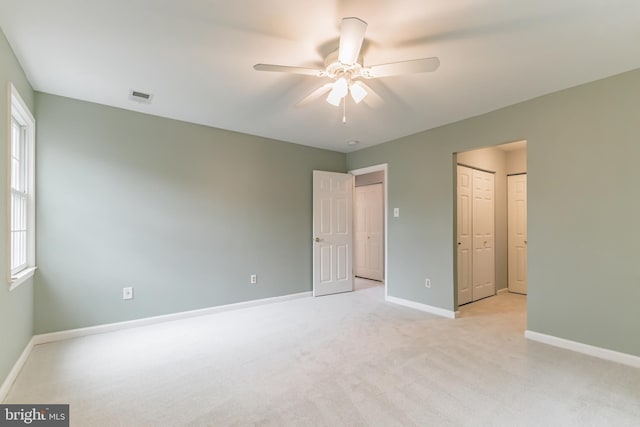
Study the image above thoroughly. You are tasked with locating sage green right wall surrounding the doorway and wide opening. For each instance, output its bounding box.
[347,70,640,355]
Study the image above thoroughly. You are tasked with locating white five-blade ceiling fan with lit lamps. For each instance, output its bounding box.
[253,17,440,111]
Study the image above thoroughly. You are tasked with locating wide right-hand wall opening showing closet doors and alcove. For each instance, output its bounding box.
[454,141,527,307]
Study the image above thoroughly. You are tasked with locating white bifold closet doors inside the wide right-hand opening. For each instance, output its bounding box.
[457,166,496,305]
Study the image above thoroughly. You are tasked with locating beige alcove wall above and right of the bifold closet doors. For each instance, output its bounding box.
[456,147,509,294]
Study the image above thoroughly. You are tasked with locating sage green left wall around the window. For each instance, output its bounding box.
[0,31,33,385]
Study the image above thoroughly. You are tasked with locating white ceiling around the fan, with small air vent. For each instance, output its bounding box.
[0,0,640,152]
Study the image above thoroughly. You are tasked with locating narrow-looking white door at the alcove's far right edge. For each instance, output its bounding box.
[507,175,527,294]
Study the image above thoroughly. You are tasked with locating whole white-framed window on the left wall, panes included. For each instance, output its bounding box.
[8,85,36,289]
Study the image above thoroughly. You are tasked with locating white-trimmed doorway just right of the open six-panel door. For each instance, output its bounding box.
[349,164,387,296]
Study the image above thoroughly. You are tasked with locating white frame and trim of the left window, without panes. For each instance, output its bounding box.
[6,82,37,290]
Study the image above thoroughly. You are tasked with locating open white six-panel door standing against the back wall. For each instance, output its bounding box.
[313,171,353,296]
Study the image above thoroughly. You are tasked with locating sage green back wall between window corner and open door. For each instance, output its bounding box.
[35,92,346,333]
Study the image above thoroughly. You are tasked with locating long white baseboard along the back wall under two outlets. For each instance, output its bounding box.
[33,292,311,345]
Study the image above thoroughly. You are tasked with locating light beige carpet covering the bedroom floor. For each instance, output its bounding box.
[6,286,640,427]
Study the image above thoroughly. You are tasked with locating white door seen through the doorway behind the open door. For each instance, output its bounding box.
[353,184,384,281]
